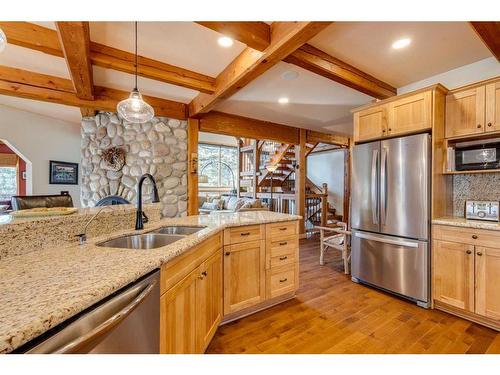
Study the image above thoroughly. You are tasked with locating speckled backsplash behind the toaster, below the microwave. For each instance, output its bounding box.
[453,173,500,217]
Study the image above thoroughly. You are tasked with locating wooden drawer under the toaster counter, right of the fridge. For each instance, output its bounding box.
[432,225,500,248]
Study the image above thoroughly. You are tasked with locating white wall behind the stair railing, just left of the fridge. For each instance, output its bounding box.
[307,151,344,215]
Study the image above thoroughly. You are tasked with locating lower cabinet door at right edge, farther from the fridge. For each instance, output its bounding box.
[475,246,500,320]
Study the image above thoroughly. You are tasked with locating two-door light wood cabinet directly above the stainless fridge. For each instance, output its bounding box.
[354,85,446,142]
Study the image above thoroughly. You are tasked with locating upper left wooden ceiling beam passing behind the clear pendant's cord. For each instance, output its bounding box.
[0,22,215,94]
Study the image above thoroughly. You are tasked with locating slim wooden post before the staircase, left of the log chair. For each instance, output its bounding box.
[295,129,307,237]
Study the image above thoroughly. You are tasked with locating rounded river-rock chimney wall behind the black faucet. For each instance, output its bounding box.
[81,112,187,217]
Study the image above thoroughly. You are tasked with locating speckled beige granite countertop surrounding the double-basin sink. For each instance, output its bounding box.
[0,211,300,353]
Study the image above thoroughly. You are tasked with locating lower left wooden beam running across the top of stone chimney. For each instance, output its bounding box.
[0,69,187,120]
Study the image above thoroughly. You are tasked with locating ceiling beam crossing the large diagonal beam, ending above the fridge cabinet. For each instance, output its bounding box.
[198,22,396,99]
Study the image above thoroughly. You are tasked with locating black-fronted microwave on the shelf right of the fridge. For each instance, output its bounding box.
[455,142,500,171]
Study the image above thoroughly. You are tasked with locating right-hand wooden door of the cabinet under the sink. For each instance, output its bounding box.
[196,249,222,353]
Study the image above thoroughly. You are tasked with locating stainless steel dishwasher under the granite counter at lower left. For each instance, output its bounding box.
[20,271,160,354]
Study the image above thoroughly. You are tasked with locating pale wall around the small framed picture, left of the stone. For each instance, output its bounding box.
[0,105,81,206]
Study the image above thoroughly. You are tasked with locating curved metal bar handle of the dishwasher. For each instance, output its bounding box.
[45,279,157,354]
